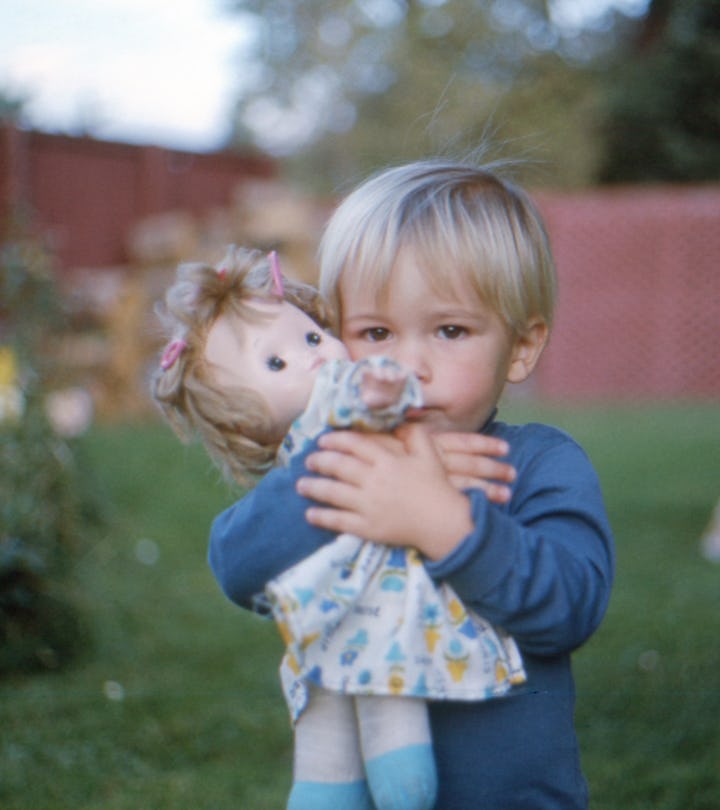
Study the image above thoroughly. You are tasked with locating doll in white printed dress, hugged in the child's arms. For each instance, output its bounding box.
[153,248,524,810]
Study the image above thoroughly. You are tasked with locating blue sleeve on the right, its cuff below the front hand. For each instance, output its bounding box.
[426,426,614,655]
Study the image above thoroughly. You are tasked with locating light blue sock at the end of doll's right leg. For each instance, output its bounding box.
[365,743,437,810]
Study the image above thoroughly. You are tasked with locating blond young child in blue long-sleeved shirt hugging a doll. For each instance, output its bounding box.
[210,161,614,810]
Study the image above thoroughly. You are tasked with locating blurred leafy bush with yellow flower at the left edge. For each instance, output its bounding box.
[0,242,98,675]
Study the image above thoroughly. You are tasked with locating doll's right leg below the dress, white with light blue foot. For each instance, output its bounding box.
[355,696,437,810]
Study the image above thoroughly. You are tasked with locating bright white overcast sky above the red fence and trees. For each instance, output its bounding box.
[0,0,648,152]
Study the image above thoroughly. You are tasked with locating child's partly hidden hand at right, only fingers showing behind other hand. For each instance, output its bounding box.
[433,433,516,503]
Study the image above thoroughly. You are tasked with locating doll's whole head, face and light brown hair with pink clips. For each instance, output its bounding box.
[151,246,344,484]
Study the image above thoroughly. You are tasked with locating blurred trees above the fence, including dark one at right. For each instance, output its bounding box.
[226,0,720,192]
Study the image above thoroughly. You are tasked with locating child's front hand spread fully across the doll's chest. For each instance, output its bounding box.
[297,424,473,559]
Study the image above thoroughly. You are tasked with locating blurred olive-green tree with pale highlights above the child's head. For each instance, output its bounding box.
[225,0,645,186]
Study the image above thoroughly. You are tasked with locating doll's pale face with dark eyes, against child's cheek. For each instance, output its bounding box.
[205,300,348,438]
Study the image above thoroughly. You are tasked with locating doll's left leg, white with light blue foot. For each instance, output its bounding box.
[288,689,373,810]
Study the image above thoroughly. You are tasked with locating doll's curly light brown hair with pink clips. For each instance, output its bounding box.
[150,245,328,486]
